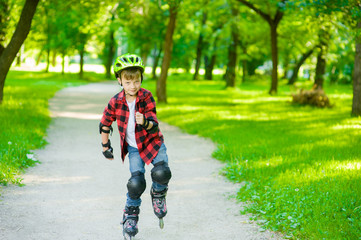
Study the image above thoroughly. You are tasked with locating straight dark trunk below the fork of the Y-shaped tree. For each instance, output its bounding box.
[269,23,278,95]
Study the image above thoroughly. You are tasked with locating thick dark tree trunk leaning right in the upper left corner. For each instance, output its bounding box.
[0,0,39,104]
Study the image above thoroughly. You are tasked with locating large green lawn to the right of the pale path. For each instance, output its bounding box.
[143,76,361,240]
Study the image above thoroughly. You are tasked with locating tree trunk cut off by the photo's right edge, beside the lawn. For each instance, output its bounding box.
[352,19,361,116]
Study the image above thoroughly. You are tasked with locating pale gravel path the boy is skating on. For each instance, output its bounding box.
[0,82,278,240]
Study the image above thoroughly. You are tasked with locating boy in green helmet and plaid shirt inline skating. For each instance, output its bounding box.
[99,54,172,238]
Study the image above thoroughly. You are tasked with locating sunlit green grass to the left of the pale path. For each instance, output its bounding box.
[0,71,104,185]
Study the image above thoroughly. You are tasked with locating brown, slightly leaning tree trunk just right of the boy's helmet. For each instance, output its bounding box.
[157,5,177,103]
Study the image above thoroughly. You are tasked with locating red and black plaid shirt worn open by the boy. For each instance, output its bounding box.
[100,88,164,165]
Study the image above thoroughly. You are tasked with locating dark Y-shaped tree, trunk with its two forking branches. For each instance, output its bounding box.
[238,0,286,94]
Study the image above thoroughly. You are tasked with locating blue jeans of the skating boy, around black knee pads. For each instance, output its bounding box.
[126,143,168,206]
